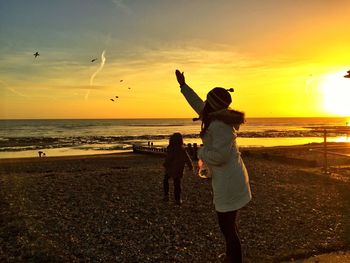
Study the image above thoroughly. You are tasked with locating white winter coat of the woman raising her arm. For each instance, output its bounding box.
[181,84,251,212]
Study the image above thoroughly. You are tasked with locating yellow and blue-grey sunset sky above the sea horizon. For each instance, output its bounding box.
[0,0,350,119]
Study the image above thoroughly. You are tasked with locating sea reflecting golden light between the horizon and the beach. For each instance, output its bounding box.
[0,118,350,158]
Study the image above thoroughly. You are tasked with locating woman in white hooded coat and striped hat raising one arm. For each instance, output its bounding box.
[175,70,251,262]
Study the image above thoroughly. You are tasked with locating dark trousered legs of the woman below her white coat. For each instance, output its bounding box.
[217,210,242,263]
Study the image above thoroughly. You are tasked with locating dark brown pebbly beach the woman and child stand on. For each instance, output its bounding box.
[0,149,350,262]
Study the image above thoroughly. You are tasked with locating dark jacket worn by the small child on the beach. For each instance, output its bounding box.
[163,147,193,178]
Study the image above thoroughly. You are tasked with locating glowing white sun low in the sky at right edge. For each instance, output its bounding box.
[321,72,350,116]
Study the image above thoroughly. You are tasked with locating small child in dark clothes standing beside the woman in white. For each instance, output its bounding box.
[163,133,193,205]
